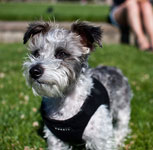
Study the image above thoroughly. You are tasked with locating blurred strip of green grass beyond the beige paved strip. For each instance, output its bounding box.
[0,2,109,21]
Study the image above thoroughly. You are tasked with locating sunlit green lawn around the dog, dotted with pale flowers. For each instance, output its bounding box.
[0,44,153,150]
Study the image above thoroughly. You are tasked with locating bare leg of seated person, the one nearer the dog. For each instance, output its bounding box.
[114,0,149,50]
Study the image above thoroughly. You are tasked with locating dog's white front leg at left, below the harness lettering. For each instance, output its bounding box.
[44,127,72,150]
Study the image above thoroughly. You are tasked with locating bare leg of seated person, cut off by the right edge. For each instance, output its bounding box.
[140,1,153,48]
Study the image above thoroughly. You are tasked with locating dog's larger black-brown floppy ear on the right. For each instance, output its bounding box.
[71,22,102,51]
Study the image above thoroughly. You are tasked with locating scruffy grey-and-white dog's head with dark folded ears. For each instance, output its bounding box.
[23,22,101,97]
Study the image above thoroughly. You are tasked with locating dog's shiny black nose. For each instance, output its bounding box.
[29,64,44,79]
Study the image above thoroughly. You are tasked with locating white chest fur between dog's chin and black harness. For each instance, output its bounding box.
[50,77,93,120]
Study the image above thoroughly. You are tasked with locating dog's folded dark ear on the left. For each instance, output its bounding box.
[23,22,50,44]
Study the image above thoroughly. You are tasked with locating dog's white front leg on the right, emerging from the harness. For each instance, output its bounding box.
[83,105,116,150]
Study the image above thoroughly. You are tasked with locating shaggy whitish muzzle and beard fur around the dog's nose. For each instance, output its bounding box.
[24,62,76,97]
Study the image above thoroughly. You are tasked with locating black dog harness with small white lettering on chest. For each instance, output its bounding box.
[41,78,109,144]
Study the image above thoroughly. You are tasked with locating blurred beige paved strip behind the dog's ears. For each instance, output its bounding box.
[0,21,134,44]
